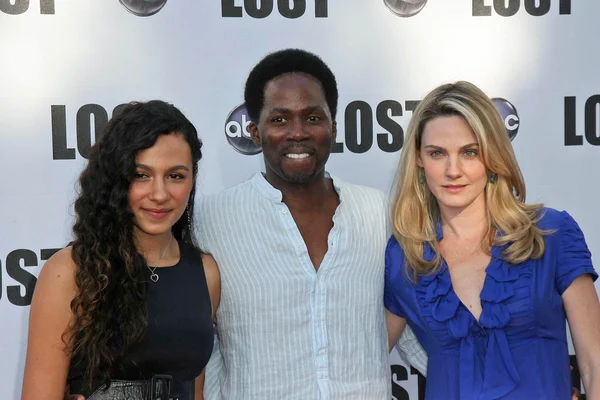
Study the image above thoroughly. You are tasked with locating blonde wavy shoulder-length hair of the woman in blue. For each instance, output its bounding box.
[391,81,549,280]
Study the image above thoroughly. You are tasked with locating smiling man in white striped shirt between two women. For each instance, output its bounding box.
[198,49,426,400]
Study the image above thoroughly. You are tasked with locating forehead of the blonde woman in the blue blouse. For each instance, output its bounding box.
[421,115,478,148]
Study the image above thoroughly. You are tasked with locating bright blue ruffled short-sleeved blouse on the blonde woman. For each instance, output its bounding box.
[384,208,598,400]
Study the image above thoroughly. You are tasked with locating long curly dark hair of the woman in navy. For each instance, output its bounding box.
[63,100,202,387]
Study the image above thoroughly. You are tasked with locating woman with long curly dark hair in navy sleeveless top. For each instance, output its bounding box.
[22,100,220,400]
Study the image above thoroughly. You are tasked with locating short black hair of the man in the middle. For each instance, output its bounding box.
[244,49,338,123]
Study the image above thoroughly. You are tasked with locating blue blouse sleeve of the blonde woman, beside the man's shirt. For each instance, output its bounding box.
[383,236,406,318]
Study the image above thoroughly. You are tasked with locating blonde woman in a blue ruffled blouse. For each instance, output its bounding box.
[385,82,600,400]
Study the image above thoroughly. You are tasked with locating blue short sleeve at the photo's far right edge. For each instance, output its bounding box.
[555,211,598,295]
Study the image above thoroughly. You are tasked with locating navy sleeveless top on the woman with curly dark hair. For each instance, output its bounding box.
[69,242,214,400]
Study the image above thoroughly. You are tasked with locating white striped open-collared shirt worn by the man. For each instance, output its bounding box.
[197,173,422,400]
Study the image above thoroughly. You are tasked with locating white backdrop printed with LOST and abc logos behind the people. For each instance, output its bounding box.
[0,0,600,400]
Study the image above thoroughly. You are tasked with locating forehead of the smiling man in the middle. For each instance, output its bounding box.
[264,72,327,109]
